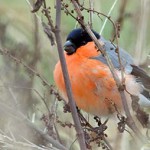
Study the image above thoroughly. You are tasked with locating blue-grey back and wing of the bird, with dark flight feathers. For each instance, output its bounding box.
[92,37,150,98]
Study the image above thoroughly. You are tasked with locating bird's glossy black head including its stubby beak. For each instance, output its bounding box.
[64,28,100,55]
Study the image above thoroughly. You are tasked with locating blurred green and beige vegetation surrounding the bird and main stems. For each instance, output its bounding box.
[0,0,150,150]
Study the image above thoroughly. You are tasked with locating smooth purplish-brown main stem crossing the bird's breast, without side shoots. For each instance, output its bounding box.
[54,0,86,150]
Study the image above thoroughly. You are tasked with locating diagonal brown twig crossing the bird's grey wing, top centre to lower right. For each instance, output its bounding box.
[72,0,144,141]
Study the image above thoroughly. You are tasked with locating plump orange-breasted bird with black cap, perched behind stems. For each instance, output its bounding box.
[53,28,150,116]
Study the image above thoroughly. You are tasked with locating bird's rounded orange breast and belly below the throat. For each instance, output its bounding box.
[54,53,121,115]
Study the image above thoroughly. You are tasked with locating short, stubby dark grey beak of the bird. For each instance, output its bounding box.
[64,41,76,55]
